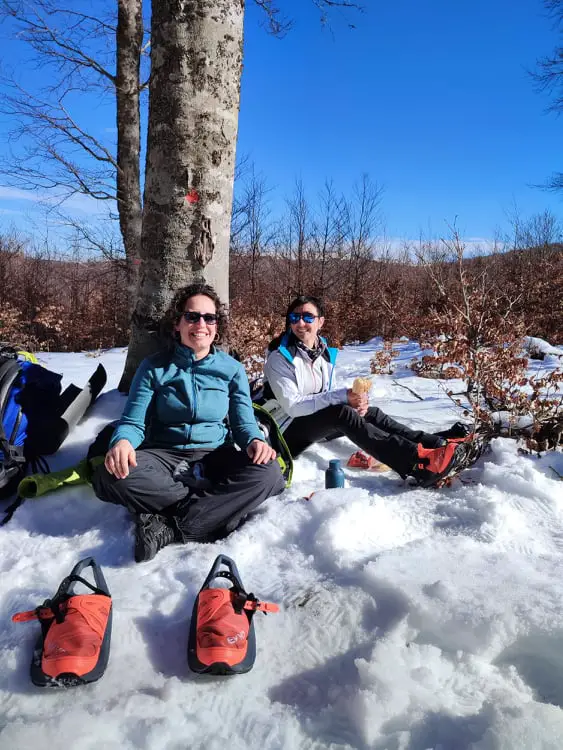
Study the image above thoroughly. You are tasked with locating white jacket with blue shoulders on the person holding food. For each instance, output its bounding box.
[264,333,347,432]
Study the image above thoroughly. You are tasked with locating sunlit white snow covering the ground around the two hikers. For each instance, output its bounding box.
[0,343,563,750]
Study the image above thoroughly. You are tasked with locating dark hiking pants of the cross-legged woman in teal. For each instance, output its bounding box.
[92,445,285,542]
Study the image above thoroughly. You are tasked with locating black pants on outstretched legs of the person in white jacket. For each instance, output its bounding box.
[283,404,440,477]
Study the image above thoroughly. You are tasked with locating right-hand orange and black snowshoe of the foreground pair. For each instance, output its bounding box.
[188,555,279,675]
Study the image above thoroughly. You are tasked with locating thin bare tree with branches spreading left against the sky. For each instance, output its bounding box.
[0,0,144,302]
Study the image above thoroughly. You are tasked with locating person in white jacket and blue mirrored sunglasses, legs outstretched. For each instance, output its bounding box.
[264,295,465,486]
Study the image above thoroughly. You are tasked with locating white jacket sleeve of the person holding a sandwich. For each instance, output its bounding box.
[264,352,348,418]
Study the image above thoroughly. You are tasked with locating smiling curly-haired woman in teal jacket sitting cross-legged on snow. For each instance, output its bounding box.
[93,284,284,562]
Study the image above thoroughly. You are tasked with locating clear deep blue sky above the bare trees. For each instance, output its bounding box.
[0,0,563,247]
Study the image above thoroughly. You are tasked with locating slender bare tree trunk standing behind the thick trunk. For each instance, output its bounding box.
[115,0,143,314]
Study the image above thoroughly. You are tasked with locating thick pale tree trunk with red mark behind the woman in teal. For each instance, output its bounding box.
[119,0,244,390]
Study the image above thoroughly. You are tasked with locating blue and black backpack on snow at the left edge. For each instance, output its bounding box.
[0,345,106,499]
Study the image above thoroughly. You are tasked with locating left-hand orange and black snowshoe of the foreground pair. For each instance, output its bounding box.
[12,557,112,687]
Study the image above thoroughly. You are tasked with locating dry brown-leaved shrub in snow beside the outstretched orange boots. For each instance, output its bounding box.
[411,234,563,447]
